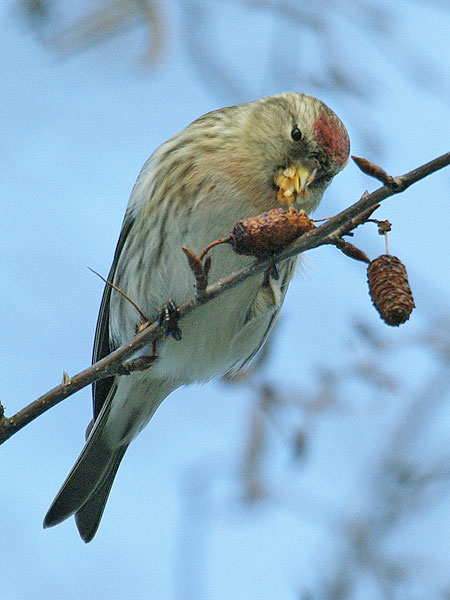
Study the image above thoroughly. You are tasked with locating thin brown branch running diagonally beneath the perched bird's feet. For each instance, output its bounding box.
[0,152,450,444]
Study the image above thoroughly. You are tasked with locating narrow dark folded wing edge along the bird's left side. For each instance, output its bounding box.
[92,213,134,420]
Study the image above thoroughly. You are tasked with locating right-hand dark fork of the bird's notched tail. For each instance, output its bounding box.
[75,445,128,542]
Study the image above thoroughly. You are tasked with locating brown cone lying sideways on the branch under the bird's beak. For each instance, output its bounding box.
[230,208,315,258]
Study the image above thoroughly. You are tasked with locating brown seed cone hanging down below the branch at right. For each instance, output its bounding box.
[367,254,415,326]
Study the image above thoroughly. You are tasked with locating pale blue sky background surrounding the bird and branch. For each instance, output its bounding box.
[0,2,450,600]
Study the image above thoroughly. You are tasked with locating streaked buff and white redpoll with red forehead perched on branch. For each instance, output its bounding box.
[44,92,349,542]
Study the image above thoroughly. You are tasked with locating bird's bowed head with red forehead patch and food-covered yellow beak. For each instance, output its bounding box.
[243,92,350,212]
